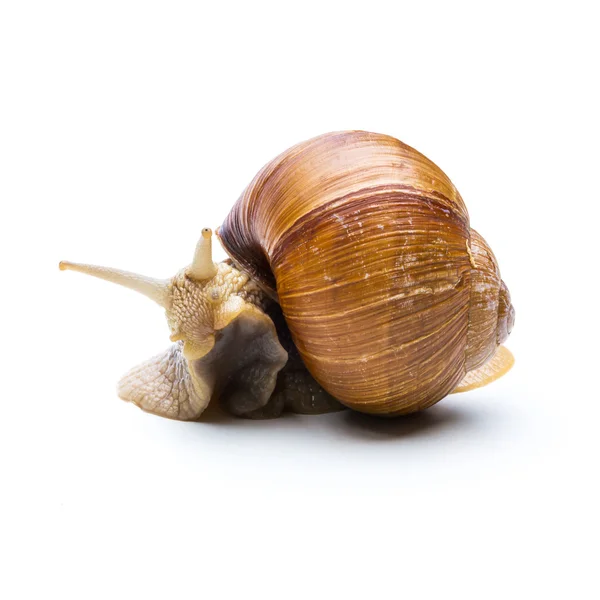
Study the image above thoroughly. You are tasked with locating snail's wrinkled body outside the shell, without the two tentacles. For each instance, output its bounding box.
[118,261,343,420]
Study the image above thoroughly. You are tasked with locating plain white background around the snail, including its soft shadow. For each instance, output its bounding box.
[0,0,600,600]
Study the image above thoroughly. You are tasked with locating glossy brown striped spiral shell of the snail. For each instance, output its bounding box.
[217,131,514,415]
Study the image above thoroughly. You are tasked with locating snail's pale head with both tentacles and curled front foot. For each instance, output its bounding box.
[60,229,288,420]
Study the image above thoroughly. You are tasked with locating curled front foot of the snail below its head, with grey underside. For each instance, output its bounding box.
[118,298,287,421]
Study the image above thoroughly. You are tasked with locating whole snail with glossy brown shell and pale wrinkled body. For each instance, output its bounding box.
[60,131,515,420]
